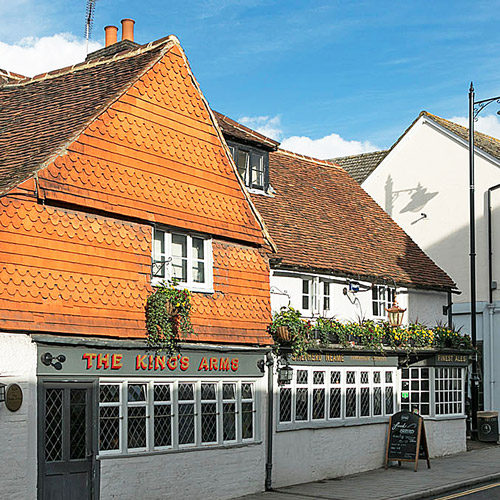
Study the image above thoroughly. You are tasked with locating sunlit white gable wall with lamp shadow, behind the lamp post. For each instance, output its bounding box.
[363,117,500,303]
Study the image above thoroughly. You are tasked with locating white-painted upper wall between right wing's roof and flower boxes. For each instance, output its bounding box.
[271,270,448,326]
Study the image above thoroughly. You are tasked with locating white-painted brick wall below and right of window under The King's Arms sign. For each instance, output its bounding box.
[100,374,267,500]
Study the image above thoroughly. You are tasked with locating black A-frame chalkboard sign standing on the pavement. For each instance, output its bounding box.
[385,411,431,471]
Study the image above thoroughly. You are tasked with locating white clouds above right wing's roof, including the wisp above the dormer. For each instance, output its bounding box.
[238,115,380,159]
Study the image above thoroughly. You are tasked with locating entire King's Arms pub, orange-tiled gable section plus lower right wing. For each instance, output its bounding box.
[0,23,467,500]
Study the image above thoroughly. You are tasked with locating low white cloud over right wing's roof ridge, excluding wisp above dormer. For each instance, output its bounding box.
[281,134,380,159]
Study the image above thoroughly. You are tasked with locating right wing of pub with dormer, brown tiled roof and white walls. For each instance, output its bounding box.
[216,113,468,487]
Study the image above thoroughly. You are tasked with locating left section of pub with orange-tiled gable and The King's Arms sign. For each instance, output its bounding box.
[0,24,273,500]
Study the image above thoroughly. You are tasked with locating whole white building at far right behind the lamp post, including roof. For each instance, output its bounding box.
[332,111,500,410]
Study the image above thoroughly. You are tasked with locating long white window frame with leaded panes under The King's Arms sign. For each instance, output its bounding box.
[99,378,260,457]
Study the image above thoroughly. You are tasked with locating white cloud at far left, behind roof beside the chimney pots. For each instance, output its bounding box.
[0,33,102,76]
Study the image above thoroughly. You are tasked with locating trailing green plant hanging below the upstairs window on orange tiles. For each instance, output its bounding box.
[146,280,194,354]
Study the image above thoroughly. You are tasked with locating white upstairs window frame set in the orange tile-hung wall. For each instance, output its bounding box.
[151,227,214,293]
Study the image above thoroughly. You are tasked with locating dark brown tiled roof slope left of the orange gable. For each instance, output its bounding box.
[0,39,169,195]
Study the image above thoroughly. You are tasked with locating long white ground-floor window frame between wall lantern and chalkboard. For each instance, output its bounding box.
[276,365,398,430]
